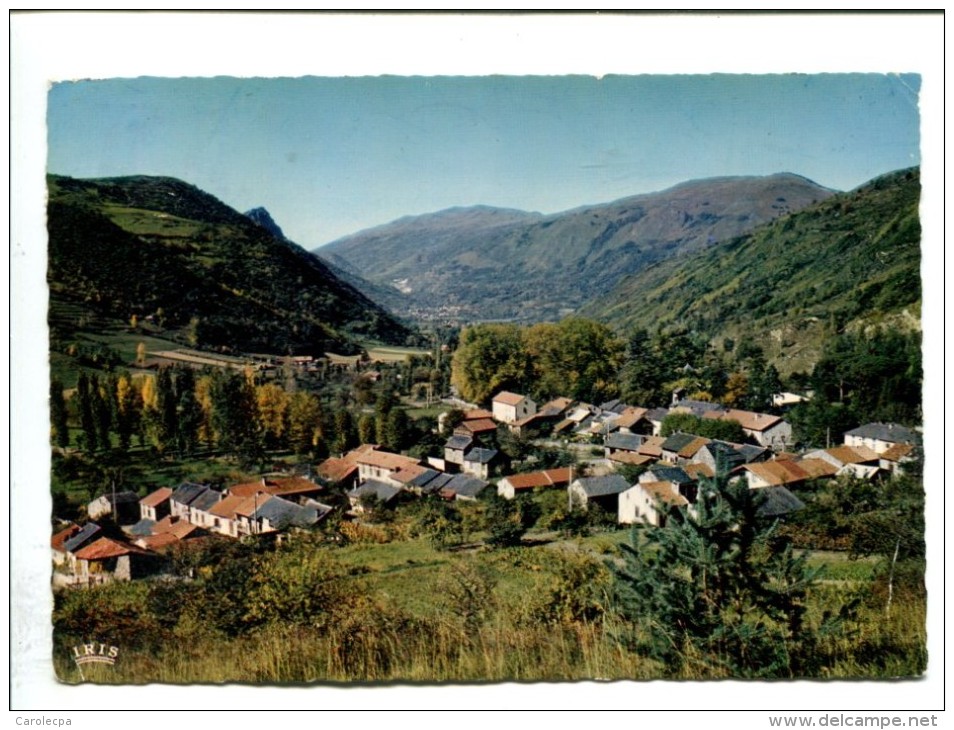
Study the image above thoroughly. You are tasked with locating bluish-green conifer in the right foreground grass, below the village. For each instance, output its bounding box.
[614,475,854,678]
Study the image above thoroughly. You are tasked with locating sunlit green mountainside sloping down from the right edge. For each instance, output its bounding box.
[581,168,921,373]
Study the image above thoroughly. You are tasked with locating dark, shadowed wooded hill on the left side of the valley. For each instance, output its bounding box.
[48,175,411,353]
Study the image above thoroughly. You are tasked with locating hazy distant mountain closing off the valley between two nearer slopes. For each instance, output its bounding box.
[315,173,833,320]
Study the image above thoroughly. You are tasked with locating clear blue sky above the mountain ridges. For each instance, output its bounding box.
[47,74,920,248]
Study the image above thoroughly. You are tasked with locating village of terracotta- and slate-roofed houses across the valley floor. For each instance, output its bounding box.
[51,378,920,588]
